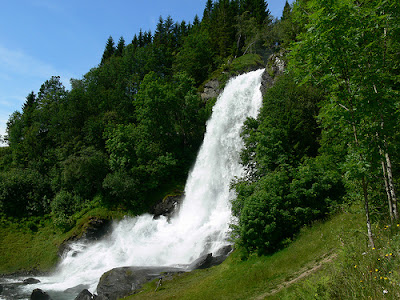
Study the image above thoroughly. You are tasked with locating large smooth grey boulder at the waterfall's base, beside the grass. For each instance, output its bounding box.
[95,267,183,300]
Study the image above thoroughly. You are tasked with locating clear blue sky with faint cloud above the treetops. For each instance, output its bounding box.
[0,0,293,145]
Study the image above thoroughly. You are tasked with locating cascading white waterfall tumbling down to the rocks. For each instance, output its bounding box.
[23,70,264,298]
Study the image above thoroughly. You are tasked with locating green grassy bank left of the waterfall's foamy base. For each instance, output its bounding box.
[0,207,124,275]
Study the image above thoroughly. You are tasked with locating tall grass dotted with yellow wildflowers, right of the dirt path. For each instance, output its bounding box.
[271,214,400,299]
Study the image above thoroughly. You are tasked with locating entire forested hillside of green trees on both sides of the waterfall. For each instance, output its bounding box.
[0,0,400,270]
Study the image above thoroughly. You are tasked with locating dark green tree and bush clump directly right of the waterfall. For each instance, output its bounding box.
[232,75,344,254]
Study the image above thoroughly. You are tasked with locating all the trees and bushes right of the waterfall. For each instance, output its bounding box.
[233,0,400,254]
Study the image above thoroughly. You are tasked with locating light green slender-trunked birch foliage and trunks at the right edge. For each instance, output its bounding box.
[290,0,399,247]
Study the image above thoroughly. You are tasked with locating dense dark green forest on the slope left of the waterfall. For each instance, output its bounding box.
[0,0,278,229]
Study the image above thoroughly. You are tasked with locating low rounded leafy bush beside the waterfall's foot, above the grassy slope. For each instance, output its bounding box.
[233,159,344,255]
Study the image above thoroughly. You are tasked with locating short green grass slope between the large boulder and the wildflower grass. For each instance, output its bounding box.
[127,213,363,299]
